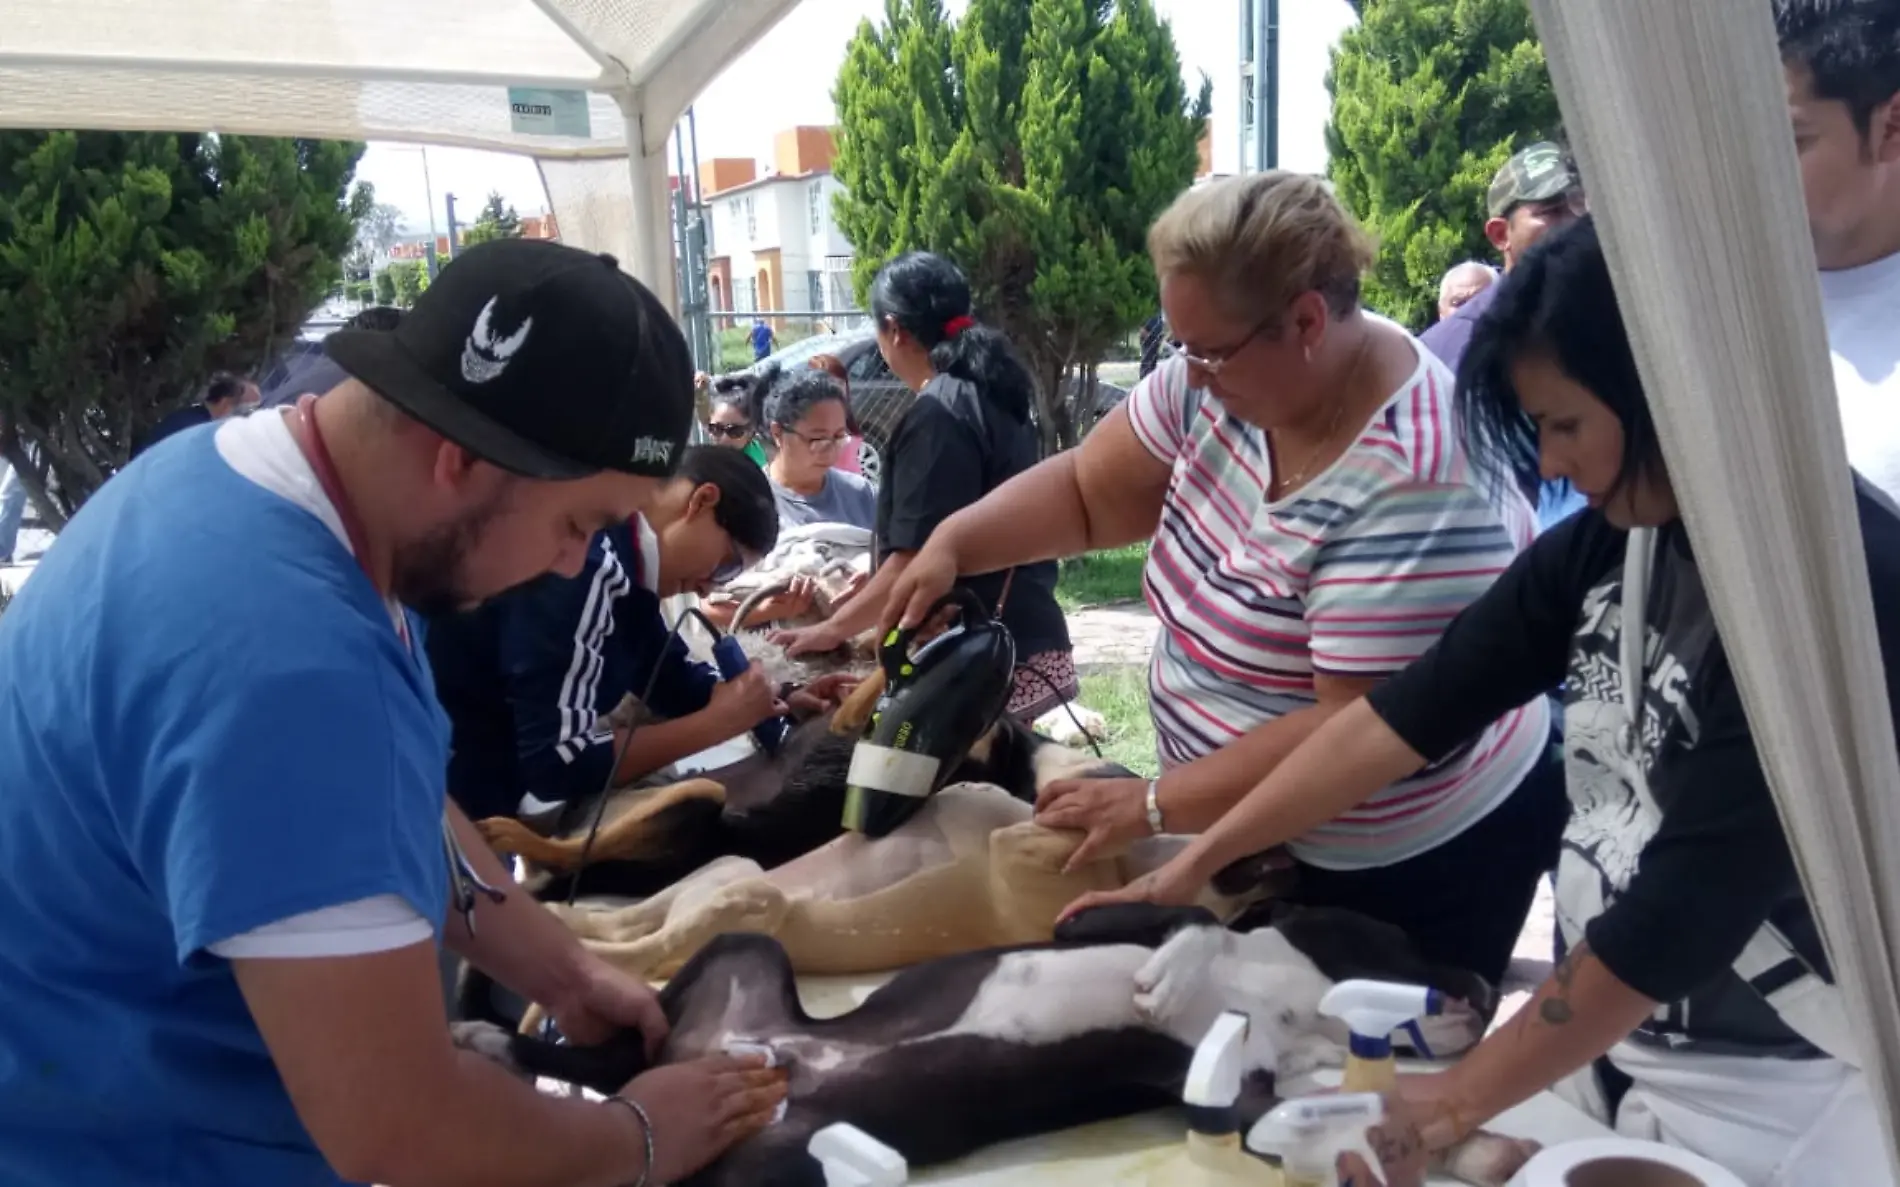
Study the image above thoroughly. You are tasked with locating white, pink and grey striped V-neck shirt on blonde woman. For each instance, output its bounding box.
[1127,334,1550,870]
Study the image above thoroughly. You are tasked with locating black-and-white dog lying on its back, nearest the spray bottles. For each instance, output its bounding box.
[458,906,1535,1187]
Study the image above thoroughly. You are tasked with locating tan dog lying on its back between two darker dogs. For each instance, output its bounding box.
[549,782,1276,978]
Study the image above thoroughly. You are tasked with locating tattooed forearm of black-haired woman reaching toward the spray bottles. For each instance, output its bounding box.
[1433,944,1657,1145]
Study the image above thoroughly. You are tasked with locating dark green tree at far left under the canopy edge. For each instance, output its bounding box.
[0,131,369,516]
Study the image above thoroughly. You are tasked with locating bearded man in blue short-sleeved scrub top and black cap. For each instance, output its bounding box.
[0,239,783,1187]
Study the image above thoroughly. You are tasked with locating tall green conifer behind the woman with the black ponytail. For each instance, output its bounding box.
[832,0,1212,452]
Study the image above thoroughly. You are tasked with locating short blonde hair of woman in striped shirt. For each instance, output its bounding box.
[1148,169,1378,321]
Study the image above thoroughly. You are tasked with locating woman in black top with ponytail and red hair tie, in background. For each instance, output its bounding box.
[773,251,1077,720]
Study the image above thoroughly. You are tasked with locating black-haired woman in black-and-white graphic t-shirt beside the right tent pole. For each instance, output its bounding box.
[1070,220,1900,1187]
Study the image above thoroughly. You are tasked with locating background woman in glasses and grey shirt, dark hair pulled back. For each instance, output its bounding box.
[766,368,878,530]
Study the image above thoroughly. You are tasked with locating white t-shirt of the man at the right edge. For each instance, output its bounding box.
[1820,254,1900,499]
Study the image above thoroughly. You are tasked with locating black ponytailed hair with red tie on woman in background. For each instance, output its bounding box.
[870,251,1036,422]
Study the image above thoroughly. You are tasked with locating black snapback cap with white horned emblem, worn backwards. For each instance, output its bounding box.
[323,239,694,479]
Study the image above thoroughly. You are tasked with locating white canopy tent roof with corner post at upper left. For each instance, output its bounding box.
[0,0,798,304]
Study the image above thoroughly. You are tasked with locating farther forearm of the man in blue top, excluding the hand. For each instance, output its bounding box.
[443,803,587,1007]
